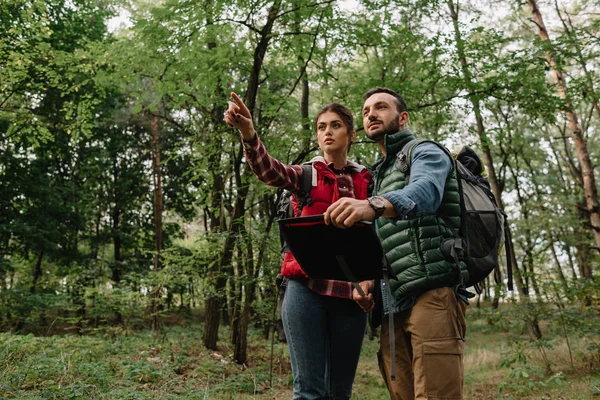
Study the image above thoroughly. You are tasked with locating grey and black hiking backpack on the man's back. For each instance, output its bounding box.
[398,139,513,294]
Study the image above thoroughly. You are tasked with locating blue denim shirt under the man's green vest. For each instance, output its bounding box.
[381,143,452,315]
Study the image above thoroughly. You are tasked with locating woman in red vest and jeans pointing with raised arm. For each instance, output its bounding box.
[224,93,372,400]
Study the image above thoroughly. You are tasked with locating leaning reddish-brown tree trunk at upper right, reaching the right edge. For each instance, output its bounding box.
[527,0,600,262]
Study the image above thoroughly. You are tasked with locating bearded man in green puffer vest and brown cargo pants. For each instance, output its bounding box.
[325,88,468,400]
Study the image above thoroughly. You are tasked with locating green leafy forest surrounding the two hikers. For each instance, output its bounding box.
[0,0,600,399]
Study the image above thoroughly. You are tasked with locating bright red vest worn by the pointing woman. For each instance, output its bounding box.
[281,162,373,279]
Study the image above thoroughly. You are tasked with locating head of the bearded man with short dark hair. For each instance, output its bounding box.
[362,93,408,142]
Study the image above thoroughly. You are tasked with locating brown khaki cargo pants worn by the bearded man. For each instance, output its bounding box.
[378,288,466,400]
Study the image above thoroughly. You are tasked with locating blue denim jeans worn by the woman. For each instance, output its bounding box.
[282,280,367,400]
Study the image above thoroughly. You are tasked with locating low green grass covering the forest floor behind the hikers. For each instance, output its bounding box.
[0,304,600,400]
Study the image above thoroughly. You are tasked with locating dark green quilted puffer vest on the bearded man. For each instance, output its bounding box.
[373,129,469,302]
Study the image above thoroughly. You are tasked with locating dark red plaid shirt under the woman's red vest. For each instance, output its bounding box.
[242,135,355,299]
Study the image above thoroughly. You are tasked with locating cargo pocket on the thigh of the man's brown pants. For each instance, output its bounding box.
[423,339,465,400]
